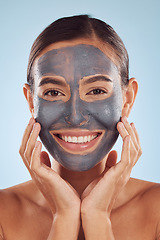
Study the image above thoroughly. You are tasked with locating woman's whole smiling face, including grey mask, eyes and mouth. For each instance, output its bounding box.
[33,41,123,171]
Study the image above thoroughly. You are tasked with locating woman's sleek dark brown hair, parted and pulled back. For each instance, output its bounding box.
[27,15,129,90]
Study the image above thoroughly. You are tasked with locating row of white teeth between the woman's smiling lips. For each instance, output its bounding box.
[61,135,98,143]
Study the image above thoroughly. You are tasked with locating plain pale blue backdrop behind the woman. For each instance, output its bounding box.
[0,0,160,188]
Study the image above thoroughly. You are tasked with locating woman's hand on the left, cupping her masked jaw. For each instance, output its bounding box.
[19,118,81,216]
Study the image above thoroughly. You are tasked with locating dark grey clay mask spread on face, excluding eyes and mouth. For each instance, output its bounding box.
[34,44,122,171]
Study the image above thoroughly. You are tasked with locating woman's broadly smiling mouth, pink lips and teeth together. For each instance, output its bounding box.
[50,130,103,155]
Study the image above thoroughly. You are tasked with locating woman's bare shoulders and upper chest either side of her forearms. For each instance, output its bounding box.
[0,162,160,240]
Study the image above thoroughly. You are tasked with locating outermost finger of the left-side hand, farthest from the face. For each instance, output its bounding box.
[19,118,35,157]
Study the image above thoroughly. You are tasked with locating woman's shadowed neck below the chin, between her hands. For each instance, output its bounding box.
[52,160,106,196]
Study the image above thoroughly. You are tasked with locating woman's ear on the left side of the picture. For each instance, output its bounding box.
[23,83,34,117]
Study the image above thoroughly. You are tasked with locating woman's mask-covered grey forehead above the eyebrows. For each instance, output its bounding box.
[37,44,118,81]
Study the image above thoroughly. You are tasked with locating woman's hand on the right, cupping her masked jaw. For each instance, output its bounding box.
[81,117,142,218]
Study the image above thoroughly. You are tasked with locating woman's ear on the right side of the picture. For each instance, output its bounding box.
[122,78,138,117]
